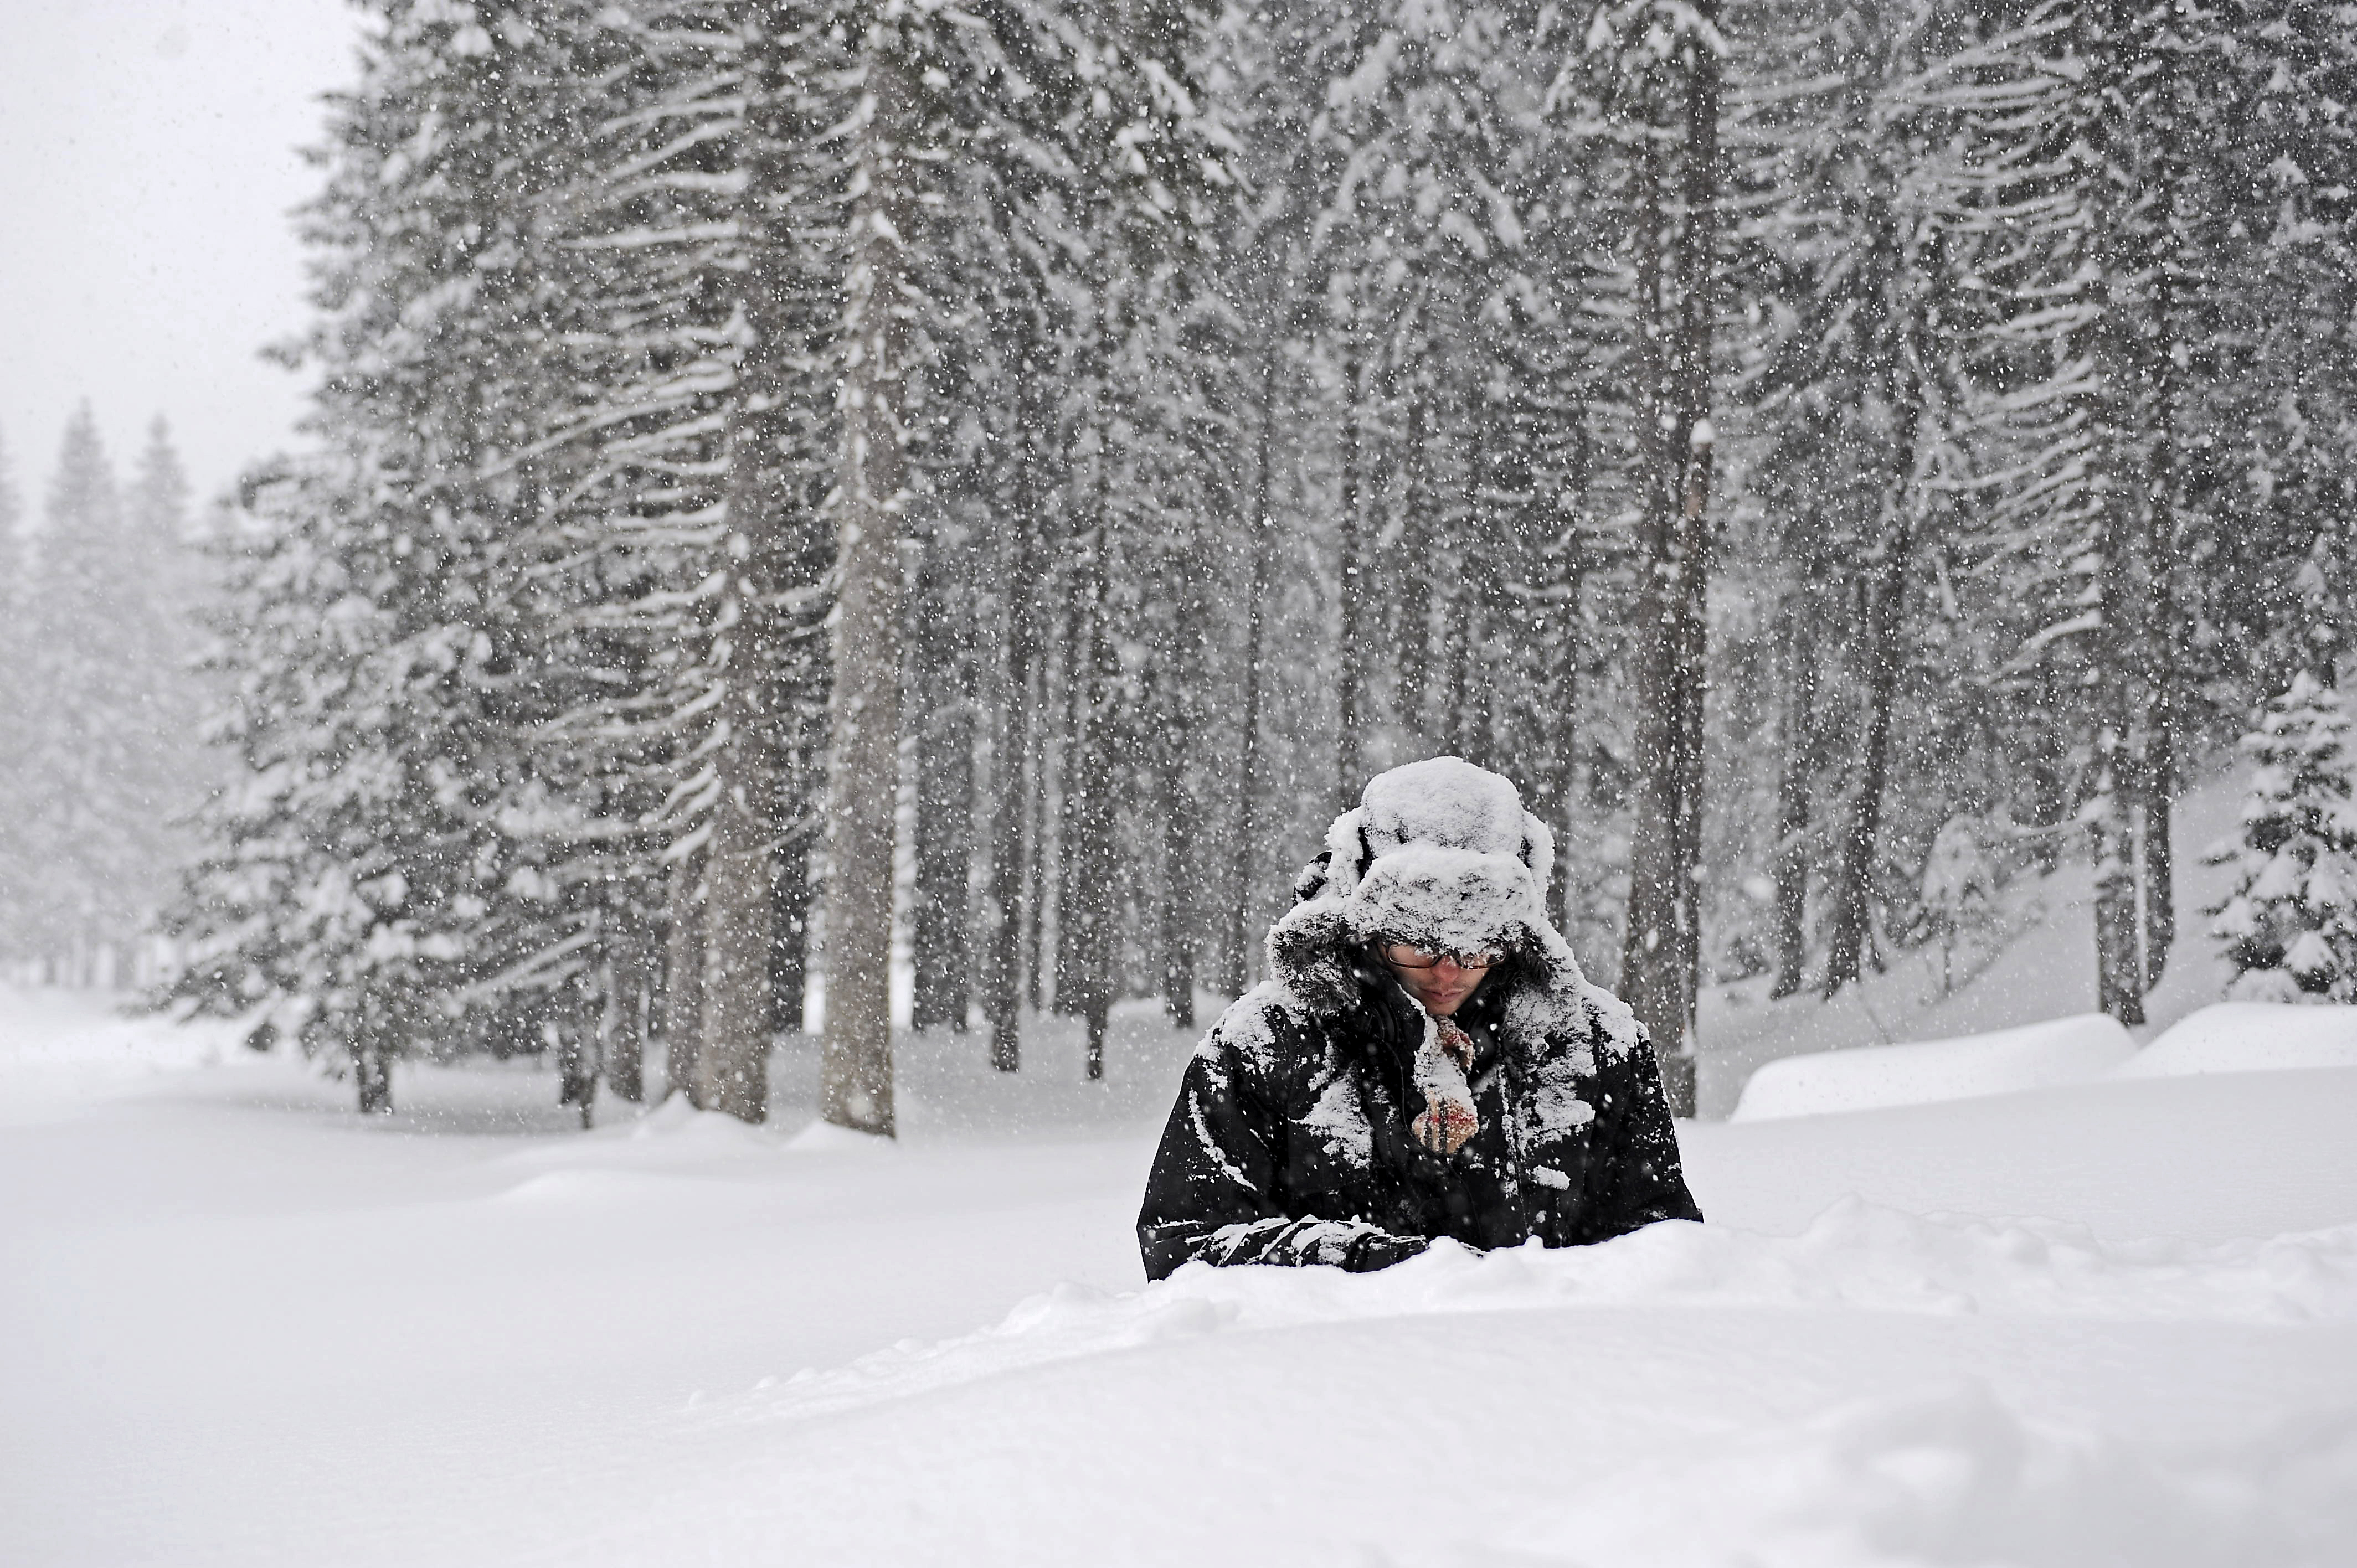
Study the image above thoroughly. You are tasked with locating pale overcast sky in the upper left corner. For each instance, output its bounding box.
[0,0,361,519]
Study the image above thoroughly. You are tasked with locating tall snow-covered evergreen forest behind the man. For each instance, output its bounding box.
[0,0,2357,1132]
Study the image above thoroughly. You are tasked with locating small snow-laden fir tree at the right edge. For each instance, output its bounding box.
[2211,669,2357,1004]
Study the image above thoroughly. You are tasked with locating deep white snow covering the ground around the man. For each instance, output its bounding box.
[14,991,2357,1568]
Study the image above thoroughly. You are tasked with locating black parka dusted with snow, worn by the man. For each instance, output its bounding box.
[1139,920,1702,1280]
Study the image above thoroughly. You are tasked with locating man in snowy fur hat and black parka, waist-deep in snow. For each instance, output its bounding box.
[1139,757,1702,1278]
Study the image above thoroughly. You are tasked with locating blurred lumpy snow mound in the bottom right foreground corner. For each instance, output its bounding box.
[1485,1382,2357,1568]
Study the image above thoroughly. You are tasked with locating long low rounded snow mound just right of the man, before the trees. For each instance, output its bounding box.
[1728,1009,2140,1122]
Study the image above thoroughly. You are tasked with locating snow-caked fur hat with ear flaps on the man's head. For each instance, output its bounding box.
[1268,757,1582,1004]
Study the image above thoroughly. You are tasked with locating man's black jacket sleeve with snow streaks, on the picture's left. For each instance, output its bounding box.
[1139,1021,1428,1280]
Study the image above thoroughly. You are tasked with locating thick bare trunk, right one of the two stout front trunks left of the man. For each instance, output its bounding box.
[820,27,919,1134]
